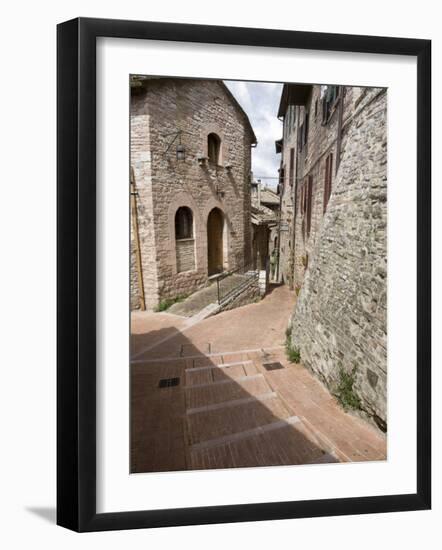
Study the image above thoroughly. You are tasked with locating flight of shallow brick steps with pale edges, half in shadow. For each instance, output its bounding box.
[184,349,337,470]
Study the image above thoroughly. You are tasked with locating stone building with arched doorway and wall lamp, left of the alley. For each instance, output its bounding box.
[130,76,256,310]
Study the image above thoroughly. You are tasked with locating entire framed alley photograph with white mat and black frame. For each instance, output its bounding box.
[57,18,431,531]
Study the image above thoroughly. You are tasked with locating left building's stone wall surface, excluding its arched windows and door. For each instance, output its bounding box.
[131,78,253,309]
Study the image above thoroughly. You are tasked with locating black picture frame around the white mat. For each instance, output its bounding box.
[57,18,431,531]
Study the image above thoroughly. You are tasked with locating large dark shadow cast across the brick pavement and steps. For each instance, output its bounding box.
[130,328,337,473]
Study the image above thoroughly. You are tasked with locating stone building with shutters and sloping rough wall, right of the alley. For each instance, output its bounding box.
[276,85,387,429]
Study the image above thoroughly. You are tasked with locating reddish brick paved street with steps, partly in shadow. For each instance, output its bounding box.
[131,286,386,472]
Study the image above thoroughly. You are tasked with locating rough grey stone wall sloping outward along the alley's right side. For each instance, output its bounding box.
[291,89,387,428]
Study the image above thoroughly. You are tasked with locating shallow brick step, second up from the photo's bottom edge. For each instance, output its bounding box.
[187,392,292,445]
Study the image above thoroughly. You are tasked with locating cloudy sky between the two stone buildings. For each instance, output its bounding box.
[224,80,282,188]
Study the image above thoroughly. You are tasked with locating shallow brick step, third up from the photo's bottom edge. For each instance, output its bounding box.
[185,374,272,409]
